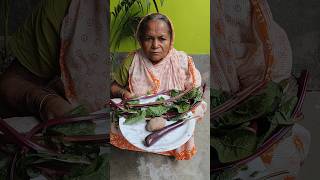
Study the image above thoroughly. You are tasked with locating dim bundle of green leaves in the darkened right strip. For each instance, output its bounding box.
[210,78,298,167]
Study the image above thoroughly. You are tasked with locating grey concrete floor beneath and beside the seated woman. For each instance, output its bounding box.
[110,91,210,180]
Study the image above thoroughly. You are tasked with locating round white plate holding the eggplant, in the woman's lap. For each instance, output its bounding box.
[119,95,196,152]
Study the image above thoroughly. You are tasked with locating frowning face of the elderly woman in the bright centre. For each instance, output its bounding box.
[141,20,171,64]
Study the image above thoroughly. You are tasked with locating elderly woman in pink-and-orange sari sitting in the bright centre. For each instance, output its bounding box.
[110,13,205,159]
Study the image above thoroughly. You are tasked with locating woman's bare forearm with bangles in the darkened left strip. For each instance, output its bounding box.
[0,61,73,120]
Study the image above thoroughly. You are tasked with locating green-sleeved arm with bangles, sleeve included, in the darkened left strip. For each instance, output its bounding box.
[0,0,74,120]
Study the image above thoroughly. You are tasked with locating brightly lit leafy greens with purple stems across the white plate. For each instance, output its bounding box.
[113,87,203,125]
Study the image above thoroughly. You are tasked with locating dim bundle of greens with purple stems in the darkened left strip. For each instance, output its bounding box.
[0,110,109,180]
